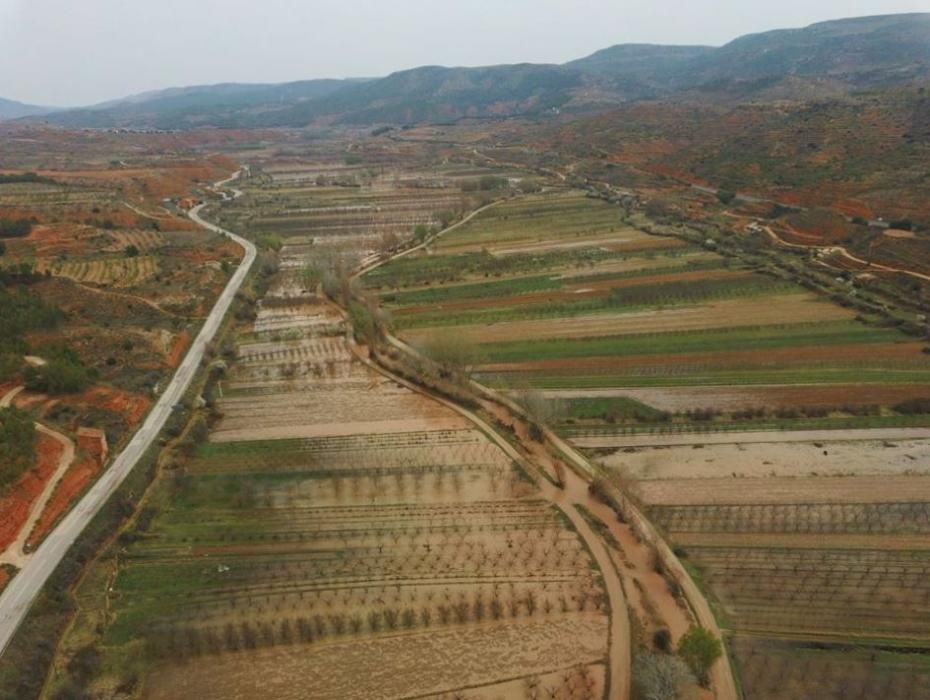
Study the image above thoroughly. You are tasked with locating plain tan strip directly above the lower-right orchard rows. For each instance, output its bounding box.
[633,474,930,505]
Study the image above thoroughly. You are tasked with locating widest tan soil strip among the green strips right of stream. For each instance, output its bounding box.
[406,294,854,343]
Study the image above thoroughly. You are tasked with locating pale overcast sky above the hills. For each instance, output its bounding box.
[0,0,930,107]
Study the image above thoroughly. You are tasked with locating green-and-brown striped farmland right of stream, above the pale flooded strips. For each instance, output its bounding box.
[365,189,930,443]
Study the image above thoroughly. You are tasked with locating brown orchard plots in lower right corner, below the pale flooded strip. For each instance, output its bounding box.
[640,476,930,700]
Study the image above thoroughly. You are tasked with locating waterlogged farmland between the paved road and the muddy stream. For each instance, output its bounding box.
[43,246,610,699]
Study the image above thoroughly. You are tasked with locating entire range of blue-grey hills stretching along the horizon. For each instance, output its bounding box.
[27,14,930,129]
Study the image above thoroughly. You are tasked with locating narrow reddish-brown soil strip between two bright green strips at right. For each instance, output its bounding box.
[480,342,924,373]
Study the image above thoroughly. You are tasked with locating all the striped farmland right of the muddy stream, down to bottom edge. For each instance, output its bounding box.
[365,171,930,699]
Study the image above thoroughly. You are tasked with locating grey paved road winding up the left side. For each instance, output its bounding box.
[0,173,256,653]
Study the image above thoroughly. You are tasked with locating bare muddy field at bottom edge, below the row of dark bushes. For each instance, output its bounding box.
[147,617,606,700]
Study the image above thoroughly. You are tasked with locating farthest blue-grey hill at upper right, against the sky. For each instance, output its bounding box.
[567,13,930,98]
